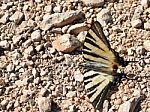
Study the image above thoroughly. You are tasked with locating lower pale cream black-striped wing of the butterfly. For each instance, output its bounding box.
[84,70,114,110]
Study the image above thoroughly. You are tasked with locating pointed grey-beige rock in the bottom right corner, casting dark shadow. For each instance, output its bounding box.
[118,96,142,112]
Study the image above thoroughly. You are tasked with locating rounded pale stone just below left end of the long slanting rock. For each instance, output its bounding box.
[31,30,41,42]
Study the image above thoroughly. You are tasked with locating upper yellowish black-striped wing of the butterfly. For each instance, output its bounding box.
[83,21,121,69]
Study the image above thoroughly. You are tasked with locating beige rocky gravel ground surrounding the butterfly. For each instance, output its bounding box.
[0,0,150,112]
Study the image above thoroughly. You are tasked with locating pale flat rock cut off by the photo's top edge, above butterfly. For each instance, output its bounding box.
[82,0,104,7]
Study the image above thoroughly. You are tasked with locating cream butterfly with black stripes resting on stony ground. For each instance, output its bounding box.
[82,21,127,110]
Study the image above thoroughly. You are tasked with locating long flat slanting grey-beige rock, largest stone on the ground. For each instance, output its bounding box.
[40,11,84,30]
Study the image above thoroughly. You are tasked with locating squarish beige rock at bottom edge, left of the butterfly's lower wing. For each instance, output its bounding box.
[38,97,51,112]
